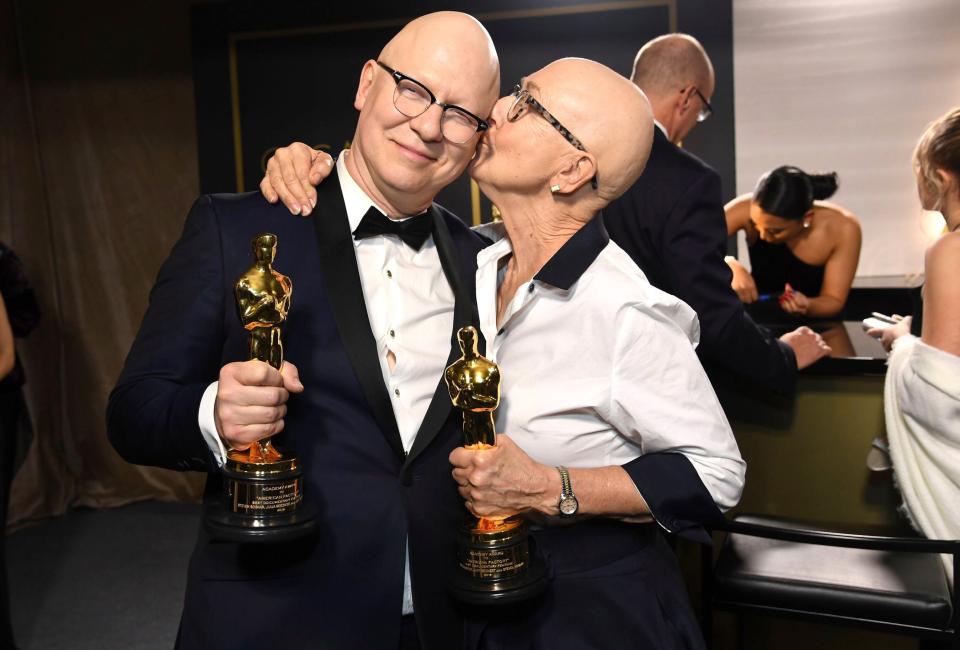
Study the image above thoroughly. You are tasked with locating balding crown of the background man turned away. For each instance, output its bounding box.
[632,34,713,98]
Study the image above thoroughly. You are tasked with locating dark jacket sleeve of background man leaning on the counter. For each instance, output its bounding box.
[661,170,797,394]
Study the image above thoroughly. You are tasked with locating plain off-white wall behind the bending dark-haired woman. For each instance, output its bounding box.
[733,0,960,276]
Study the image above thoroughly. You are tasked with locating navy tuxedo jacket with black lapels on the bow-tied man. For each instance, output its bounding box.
[107,171,484,650]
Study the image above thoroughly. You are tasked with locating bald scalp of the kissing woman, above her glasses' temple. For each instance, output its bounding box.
[528,58,653,204]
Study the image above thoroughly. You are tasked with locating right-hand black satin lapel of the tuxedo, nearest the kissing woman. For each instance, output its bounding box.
[404,206,476,467]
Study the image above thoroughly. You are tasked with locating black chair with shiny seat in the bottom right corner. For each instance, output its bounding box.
[701,515,960,649]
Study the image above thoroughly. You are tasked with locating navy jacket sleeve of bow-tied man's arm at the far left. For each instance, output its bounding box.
[107,196,224,471]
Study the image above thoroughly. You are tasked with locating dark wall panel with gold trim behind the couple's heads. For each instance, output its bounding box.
[193,0,735,221]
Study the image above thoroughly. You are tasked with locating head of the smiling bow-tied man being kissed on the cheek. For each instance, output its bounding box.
[346,11,500,215]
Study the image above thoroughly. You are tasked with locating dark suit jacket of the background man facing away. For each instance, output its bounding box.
[603,128,797,393]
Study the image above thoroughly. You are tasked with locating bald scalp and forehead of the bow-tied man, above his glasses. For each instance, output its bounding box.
[380,11,500,100]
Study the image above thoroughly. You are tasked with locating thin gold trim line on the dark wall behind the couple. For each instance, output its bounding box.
[227,0,678,224]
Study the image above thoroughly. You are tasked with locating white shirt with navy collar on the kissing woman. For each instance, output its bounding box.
[477,217,746,509]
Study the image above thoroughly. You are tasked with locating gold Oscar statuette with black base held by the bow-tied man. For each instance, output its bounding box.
[206,233,315,542]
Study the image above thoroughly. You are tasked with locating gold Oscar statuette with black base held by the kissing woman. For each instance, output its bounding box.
[444,326,547,605]
